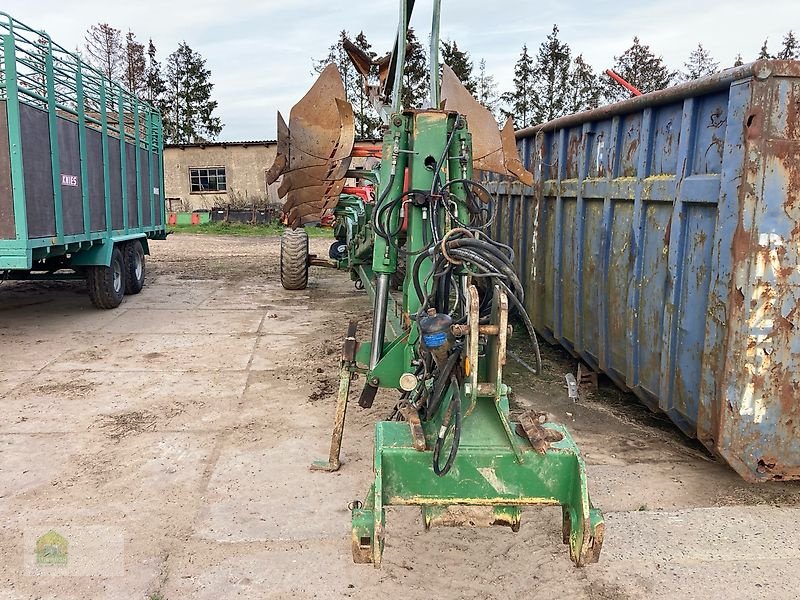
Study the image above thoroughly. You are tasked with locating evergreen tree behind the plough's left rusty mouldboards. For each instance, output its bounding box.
[314,30,381,139]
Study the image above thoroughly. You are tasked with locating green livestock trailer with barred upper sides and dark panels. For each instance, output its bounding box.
[0,12,166,308]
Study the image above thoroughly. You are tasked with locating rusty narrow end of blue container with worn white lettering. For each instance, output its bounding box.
[717,72,800,479]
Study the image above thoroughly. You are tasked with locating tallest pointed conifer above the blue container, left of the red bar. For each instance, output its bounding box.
[532,25,572,123]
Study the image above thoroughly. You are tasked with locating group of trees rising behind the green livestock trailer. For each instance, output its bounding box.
[78,23,223,144]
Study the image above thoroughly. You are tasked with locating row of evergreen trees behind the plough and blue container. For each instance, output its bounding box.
[314,25,800,138]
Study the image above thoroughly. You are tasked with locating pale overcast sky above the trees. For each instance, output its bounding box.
[2,0,800,140]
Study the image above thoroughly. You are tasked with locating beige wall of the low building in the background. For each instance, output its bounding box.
[164,142,280,210]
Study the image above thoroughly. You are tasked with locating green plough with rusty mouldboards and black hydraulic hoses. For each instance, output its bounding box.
[270,1,604,566]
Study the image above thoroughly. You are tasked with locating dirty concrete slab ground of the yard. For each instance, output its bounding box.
[0,234,800,600]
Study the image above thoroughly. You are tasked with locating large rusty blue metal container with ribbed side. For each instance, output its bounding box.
[492,61,800,481]
